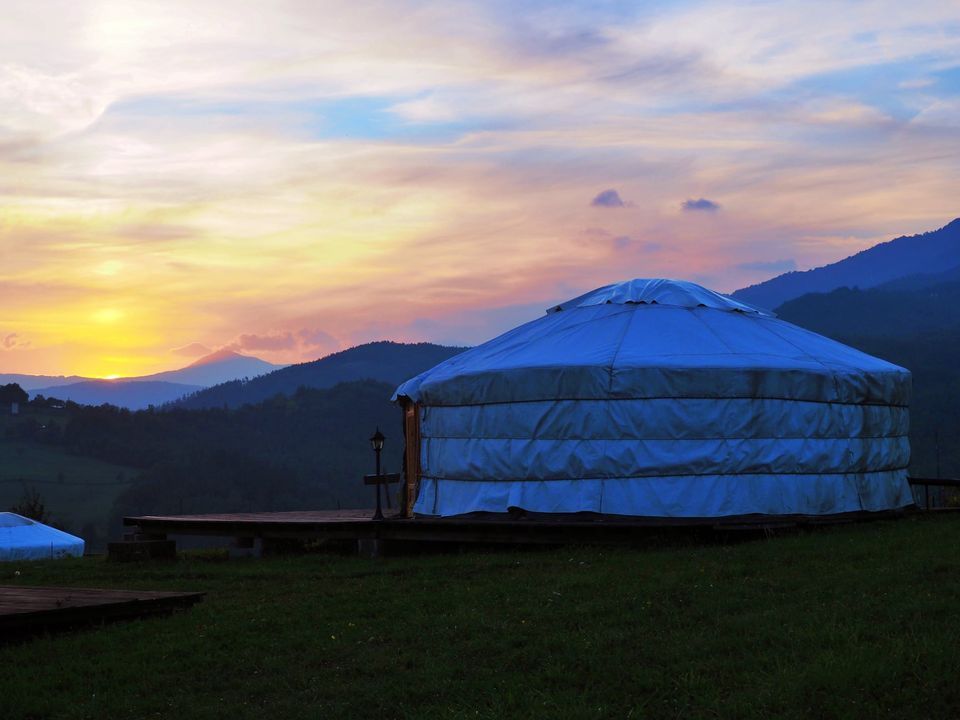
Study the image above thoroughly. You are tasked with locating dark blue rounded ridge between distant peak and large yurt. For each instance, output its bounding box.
[173,341,466,410]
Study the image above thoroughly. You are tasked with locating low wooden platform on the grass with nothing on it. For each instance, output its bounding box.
[0,585,204,642]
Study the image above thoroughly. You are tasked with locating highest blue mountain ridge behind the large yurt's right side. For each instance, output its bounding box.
[732,218,960,308]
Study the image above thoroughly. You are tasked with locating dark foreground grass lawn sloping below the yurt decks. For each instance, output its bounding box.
[0,517,960,720]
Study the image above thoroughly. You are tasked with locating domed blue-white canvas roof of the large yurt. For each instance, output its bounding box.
[394,279,910,405]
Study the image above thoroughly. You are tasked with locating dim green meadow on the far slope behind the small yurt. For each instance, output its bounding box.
[0,435,139,537]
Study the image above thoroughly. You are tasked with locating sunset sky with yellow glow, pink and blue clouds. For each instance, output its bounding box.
[0,0,960,376]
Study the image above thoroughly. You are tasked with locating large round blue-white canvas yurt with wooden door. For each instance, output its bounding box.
[394,279,912,519]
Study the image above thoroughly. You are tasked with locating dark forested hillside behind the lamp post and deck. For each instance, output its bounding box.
[43,381,403,518]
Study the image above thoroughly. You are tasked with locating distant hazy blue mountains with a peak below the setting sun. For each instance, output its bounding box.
[22,350,283,410]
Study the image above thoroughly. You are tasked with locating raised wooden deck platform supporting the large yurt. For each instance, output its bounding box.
[123,510,900,547]
